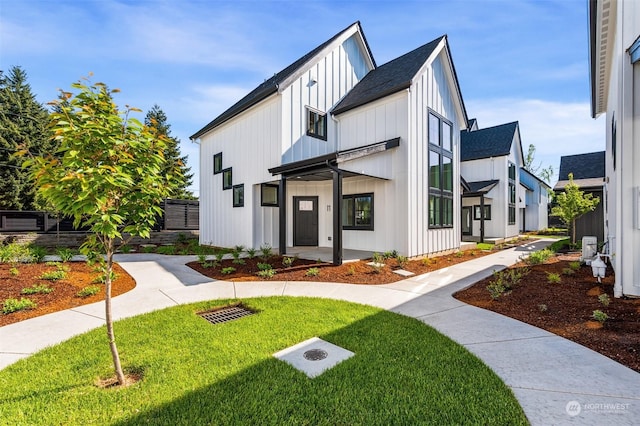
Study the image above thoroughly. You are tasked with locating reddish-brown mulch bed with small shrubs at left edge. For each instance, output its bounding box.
[0,262,136,326]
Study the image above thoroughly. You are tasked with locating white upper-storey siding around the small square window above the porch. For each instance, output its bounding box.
[281,34,370,164]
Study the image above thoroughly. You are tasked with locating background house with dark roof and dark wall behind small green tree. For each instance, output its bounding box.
[553,151,605,244]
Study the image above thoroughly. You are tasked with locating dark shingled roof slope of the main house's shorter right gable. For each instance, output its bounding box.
[332,35,446,115]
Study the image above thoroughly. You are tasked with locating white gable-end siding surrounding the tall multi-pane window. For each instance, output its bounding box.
[406,49,466,256]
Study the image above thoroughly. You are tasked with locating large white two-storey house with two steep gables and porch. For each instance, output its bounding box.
[191,22,467,263]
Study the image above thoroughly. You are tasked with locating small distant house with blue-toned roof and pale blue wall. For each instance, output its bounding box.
[520,168,551,232]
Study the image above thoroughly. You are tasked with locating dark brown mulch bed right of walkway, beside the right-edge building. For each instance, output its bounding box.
[454,257,640,372]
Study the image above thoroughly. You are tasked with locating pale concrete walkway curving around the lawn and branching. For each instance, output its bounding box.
[0,240,640,425]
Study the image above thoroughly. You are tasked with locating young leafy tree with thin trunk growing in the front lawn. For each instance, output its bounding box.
[25,77,180,385]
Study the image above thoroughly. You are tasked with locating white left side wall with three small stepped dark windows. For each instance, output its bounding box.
[200,95,282,247]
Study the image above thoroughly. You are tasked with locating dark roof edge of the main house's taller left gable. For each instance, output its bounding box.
[189,21,376,139]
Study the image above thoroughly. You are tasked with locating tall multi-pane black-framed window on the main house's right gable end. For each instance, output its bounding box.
[428,111,453,228]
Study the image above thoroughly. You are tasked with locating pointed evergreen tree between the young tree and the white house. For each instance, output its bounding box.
[144,105,195,200]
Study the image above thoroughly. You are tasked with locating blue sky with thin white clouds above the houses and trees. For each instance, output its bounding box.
[0,0,604,194]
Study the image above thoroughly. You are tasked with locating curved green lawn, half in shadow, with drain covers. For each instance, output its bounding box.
[0,297,527,425]
